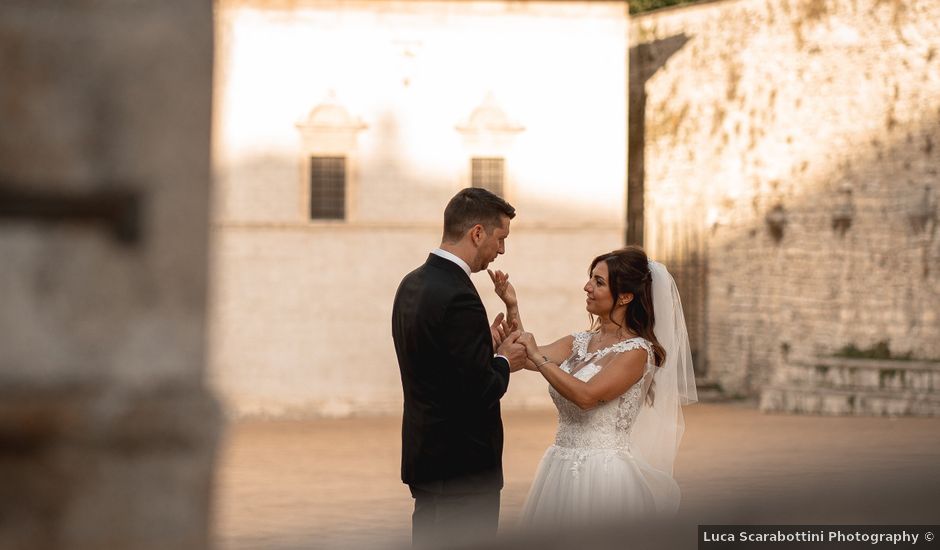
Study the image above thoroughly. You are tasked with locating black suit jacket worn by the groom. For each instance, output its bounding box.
[392,254,509,493]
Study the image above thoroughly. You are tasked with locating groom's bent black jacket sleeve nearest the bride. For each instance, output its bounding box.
[444,292,509,407]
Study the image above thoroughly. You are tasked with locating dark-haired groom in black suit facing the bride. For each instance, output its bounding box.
[392,188,526,546]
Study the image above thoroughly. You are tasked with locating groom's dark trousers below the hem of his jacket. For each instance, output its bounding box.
[411,487,499,548]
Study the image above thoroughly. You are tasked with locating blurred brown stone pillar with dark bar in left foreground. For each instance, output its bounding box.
[0,0,220,550]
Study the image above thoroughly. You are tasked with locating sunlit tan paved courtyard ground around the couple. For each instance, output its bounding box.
[214,403,940,550]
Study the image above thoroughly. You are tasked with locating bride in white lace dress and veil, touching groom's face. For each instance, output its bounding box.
[488,246,697,528]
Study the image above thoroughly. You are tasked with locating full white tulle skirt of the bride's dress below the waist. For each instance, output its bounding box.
[520,445,679,528]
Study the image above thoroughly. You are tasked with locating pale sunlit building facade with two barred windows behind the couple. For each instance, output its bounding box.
[210,0,628,416]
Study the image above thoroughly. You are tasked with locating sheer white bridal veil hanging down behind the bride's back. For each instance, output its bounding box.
[631,261,698,508]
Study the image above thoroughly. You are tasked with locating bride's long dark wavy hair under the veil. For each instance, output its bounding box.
[588,246,666,366]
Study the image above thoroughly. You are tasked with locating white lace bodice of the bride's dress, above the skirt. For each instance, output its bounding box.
[548,332,653,452]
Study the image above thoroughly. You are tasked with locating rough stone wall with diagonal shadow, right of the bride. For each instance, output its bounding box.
[631,0,940,394]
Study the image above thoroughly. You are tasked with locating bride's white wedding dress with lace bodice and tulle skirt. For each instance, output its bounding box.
[522,332,679,528]
